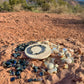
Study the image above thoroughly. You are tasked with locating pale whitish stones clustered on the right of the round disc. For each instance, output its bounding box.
[44,42,74,74]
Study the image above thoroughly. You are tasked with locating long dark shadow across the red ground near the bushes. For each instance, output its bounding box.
[52,18,84,28]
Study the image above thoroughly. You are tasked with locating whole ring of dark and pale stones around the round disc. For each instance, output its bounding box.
[2,41,74,82]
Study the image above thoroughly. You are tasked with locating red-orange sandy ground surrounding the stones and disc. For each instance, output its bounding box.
[0,11,84,84]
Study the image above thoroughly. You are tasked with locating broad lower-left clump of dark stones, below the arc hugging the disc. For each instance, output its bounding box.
[2,59,29,81]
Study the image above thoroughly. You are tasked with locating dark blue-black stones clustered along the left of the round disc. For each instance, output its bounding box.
[2,41,42,82]
